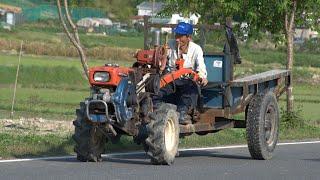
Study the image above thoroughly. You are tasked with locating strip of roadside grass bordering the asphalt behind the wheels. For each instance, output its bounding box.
[0,127,320,159]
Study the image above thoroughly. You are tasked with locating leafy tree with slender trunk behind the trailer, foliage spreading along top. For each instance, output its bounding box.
[164,0,320,112]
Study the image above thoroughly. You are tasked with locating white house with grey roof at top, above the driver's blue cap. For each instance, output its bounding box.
[137,1,164,16]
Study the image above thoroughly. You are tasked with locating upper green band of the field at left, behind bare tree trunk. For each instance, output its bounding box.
[0,55,132,90]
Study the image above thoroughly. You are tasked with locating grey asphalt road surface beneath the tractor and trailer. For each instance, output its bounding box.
[0,141,320,180]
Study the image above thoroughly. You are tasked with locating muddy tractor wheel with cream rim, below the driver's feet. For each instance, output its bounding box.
[145,103,180,165]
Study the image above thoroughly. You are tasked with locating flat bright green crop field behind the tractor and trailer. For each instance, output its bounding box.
[0,52,320,121]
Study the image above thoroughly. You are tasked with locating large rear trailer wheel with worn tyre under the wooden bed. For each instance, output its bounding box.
[246,91,279,160]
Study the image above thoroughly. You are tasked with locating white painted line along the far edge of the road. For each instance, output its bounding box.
[0,141,320,163]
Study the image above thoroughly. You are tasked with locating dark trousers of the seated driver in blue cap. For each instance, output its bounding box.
[152,79,198,112]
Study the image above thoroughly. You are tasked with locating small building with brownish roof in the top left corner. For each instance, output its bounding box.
[0,3,22,26]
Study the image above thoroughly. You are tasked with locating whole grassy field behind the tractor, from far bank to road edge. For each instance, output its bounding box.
[0,27,320,158]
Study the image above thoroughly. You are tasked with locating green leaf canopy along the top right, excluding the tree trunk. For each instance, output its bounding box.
[163,0,320,40]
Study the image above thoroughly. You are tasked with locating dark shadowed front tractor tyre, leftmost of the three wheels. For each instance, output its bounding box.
[72,102,107,162]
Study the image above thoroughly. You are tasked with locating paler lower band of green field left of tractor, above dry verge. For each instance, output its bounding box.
[0,88,89,120]
